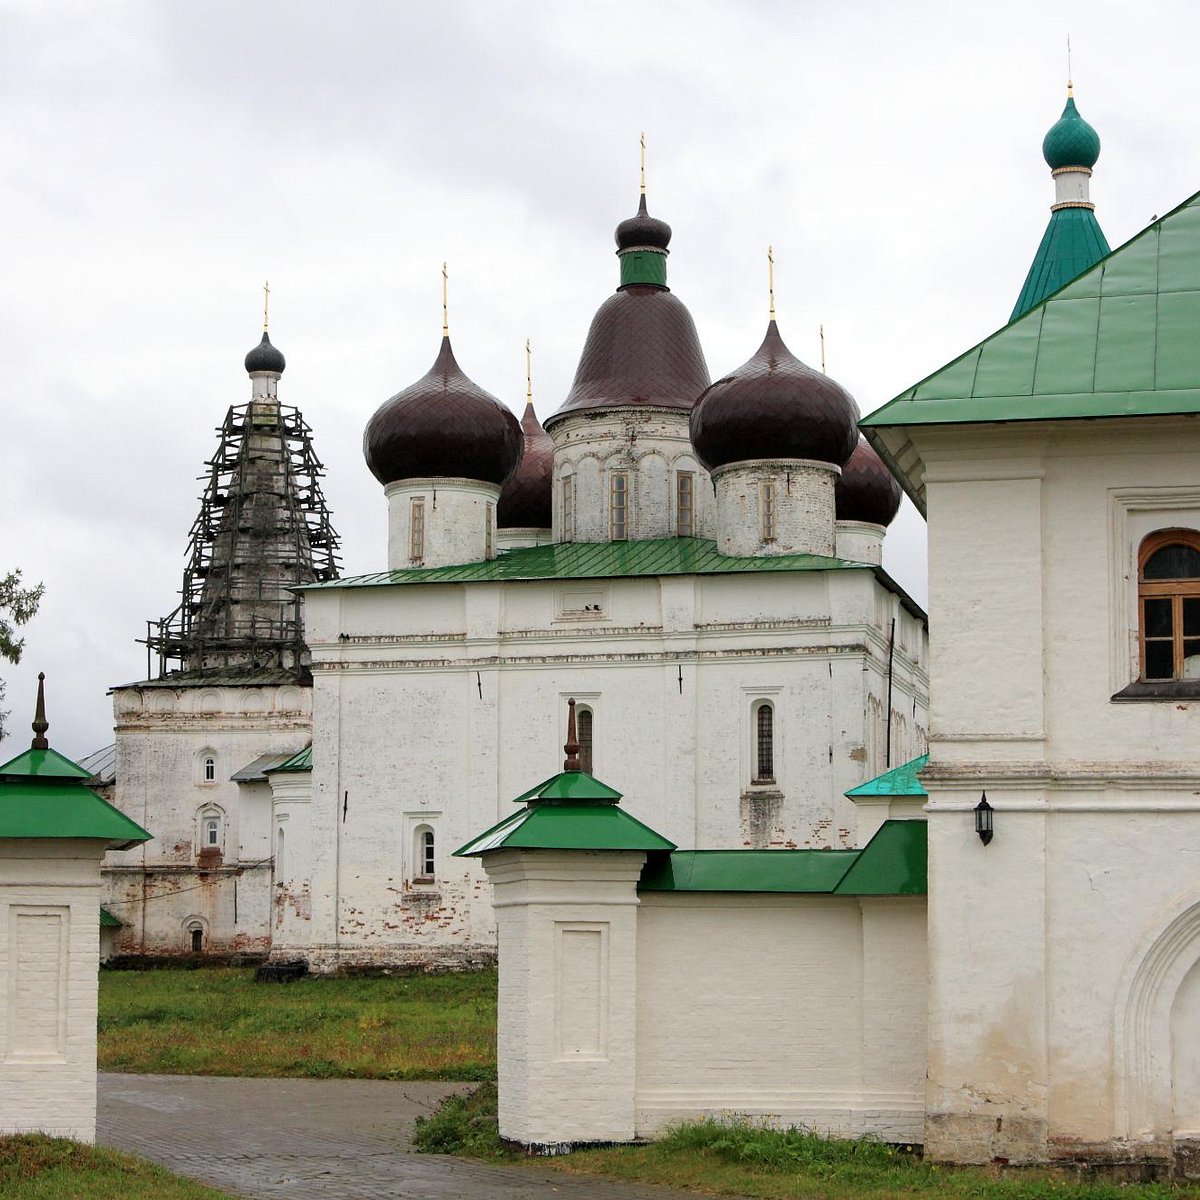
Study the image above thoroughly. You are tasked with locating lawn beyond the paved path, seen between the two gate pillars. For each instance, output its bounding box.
[98,967,496,1080]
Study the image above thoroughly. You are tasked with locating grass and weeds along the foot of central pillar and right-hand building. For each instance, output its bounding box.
[415,1085,1200,1200]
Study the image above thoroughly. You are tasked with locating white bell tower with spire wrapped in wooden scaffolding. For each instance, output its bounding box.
[103,304,338,956]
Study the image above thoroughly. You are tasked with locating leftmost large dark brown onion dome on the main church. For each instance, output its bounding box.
[362,337,522,485]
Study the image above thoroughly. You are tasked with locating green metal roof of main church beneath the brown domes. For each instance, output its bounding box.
[298,538,864,592]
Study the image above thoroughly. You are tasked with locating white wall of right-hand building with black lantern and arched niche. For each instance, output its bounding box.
[923,418,1200,1162]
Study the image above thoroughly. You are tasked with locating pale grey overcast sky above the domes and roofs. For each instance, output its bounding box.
[0,0,1200,757]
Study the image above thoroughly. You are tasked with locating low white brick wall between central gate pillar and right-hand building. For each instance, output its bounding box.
[638,892,926,1142]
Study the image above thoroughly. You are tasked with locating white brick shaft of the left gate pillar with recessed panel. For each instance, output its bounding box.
[0,839,100,1142]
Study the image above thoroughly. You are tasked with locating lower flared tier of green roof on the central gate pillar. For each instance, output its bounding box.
[455,803,674,858]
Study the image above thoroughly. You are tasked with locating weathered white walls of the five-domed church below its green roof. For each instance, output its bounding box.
[292,570,925,966]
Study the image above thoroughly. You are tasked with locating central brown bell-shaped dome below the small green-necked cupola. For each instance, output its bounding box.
[546,283,709,426]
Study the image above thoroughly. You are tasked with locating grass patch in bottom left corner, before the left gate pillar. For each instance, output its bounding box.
[0,1134,229,1200]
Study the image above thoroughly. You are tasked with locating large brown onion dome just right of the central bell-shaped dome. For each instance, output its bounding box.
[691,320,858,470]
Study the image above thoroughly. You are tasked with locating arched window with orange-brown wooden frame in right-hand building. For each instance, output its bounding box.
[1138,529,1200,682]
